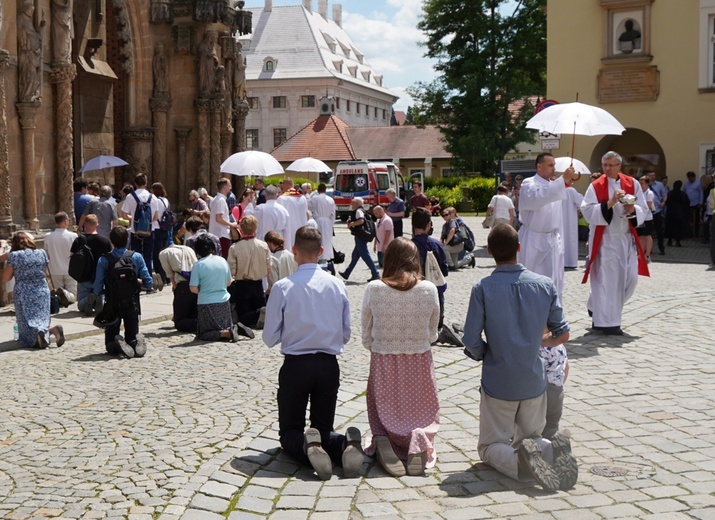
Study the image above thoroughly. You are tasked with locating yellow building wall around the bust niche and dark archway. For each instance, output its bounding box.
[547,0,715,185]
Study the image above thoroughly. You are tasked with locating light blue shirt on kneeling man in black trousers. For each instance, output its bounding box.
[263,264,350,355]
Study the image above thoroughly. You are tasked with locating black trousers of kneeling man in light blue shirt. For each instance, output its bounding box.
[278,353,345,465]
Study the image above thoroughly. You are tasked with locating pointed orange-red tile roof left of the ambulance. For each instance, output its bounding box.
[271,116,357,162]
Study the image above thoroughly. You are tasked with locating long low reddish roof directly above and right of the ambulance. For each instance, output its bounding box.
[348,125,452,161]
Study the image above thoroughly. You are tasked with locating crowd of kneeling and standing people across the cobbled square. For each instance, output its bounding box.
[0,152,715,490]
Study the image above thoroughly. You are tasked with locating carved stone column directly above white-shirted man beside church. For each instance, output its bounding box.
[50,63,77,225]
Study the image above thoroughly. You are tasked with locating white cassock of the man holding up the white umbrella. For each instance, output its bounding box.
[517,175,566,301]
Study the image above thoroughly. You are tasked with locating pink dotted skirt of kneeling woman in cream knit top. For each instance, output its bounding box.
[365,351,439,467]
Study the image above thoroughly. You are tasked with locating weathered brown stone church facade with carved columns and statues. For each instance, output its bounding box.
[0,0,251,232]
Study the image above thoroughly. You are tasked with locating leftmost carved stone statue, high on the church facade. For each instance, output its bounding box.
[17,0,42,103]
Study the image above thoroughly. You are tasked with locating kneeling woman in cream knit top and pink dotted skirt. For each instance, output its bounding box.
[362,238,439,477]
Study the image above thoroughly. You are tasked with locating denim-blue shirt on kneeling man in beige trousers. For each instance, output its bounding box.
[462,264,569,401]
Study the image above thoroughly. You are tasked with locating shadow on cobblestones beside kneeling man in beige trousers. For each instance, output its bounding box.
[439,462,554,499]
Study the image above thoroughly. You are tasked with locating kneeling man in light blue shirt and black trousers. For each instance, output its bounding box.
[263,226,364,480]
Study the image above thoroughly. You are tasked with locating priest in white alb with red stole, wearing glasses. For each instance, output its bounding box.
[581,152,650,336]
